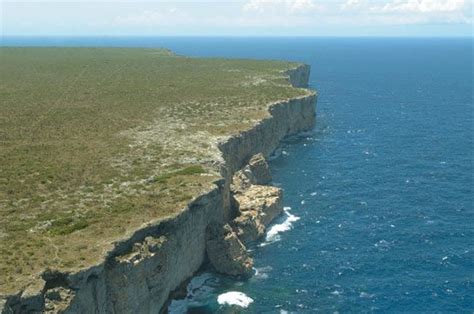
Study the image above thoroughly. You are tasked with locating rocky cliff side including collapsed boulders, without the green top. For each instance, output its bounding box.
[0,65,316,313]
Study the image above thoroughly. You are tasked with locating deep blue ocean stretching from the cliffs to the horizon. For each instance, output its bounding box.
[3,38,474,313]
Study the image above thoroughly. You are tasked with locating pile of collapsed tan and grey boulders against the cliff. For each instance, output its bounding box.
[206,154,283,268]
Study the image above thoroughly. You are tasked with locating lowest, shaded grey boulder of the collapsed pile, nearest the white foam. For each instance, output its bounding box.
[206,224,253,276]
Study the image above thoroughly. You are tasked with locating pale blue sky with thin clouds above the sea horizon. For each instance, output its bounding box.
[0,0,474,37]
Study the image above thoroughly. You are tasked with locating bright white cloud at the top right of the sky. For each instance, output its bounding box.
[373,0,466,13]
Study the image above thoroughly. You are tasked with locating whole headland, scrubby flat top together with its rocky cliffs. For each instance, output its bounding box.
[0,48,316,313]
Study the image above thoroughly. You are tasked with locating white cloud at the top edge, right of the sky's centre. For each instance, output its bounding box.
[243,0,319,14]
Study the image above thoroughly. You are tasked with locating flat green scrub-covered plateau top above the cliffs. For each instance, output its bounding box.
[0,48,305,294]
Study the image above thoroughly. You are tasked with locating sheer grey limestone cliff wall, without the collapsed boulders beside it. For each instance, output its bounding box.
[0,65,316,313]
